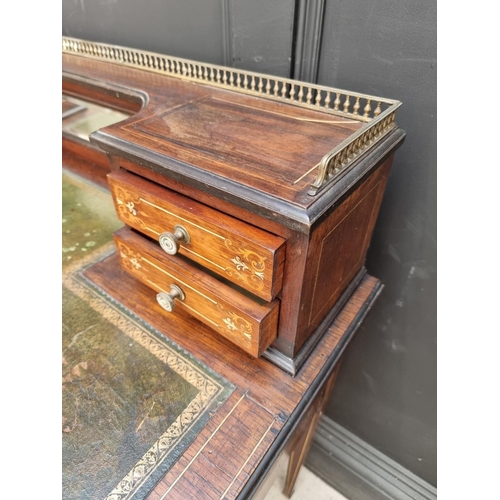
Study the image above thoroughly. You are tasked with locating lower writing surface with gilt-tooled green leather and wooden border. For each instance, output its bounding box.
[62,165,381,500]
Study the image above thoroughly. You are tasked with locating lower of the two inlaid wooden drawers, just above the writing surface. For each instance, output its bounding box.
[114,227,280,357]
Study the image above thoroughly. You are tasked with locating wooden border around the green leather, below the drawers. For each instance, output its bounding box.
[84,254,379,500]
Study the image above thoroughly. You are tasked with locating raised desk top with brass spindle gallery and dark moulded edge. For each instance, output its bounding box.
[63,38,404,230]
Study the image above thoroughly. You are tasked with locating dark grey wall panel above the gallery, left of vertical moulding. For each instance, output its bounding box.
[62,0,294,76]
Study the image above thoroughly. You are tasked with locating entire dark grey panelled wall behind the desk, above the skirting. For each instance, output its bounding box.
[62,0,437,486]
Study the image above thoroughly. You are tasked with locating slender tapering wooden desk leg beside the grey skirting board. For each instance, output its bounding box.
[283,361,340,498]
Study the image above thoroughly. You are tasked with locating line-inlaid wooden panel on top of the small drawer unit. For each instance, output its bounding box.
[128,95,360,193]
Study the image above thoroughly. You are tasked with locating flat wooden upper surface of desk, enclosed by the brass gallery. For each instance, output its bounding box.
[63,54,361,206]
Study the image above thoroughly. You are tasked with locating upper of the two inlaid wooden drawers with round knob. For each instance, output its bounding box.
[108,170,285,301]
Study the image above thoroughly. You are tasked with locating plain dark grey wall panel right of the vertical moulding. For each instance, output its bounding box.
[318,0,437,485]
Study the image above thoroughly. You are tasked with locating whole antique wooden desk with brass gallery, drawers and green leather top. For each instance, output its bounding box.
[63,39,404,500]
